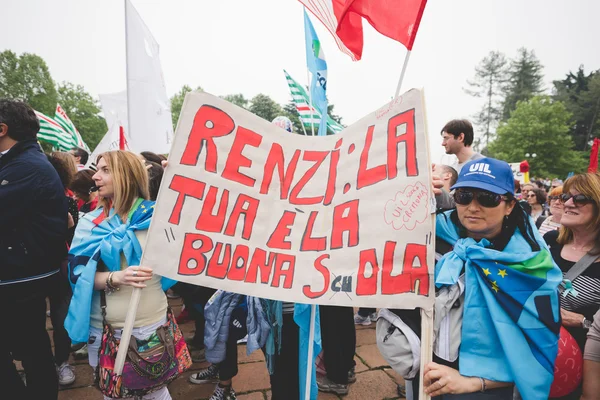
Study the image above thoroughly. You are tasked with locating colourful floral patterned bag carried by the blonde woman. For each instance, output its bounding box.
[96,292,192,399]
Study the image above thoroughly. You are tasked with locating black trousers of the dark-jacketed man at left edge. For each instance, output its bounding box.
[0,278,58,400]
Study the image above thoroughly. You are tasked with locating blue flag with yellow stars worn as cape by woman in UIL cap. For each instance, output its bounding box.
[435,211,562,400]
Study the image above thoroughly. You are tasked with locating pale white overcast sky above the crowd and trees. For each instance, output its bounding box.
[0,0,600,162]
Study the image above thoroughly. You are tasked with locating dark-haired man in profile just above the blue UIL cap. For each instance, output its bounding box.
[441,119,483,172]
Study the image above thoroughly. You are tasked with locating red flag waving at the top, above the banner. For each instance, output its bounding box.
[299,0,427,61]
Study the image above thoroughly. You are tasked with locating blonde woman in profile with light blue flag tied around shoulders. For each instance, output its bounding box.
[65,151,171,400]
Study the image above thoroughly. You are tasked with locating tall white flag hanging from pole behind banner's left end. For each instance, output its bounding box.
[125,0,173,154]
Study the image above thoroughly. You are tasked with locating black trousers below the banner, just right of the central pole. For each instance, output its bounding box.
[319,306,356,385]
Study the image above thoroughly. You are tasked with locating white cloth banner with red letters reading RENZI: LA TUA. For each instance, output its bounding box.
[142,90,434,309]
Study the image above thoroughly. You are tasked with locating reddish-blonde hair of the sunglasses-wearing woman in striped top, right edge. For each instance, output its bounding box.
[558,173,600,253]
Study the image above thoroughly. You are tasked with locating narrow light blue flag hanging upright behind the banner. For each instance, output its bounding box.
[304,10,328,136]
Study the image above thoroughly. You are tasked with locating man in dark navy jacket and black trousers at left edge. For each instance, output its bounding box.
[0,99,67,400]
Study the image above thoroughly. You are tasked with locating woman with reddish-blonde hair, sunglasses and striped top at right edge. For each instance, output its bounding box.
[544,173,600,398]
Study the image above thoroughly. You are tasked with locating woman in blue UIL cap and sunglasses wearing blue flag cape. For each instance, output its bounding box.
[413,158,562,400]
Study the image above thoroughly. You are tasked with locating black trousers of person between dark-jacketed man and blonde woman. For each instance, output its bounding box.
[49,275,73,365]
